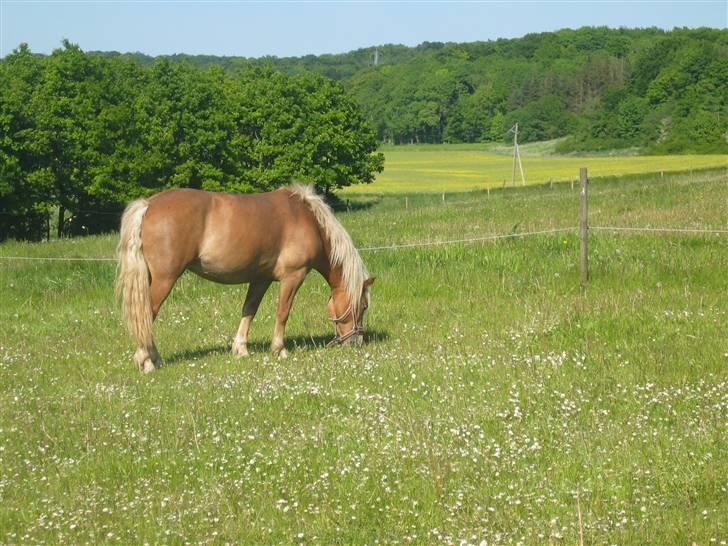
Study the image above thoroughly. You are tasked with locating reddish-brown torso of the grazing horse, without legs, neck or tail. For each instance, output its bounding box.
[143,189,321,283]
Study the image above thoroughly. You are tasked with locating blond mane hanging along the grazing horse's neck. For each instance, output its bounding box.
[288,184,369,310]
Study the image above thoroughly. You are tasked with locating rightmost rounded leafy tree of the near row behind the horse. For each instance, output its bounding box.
[228,69,384,191]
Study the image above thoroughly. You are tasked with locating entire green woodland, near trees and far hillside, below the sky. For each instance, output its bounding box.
[0,27,728,240]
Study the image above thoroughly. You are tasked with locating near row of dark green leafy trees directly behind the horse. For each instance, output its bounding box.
[0,41,384,240]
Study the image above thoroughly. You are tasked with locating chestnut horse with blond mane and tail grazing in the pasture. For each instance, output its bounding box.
[116,185,374,372]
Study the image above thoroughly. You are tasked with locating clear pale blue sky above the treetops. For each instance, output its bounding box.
[0,0,728,57]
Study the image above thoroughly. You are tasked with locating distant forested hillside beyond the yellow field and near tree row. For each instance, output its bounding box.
[96,27,728,152]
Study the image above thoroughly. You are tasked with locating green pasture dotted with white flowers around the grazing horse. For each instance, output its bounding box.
[0,169,728,545]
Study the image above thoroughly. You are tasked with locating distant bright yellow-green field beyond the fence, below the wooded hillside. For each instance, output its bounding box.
[345,143,728,195]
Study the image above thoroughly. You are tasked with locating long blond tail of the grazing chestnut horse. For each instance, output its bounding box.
[116,199,153,349]
